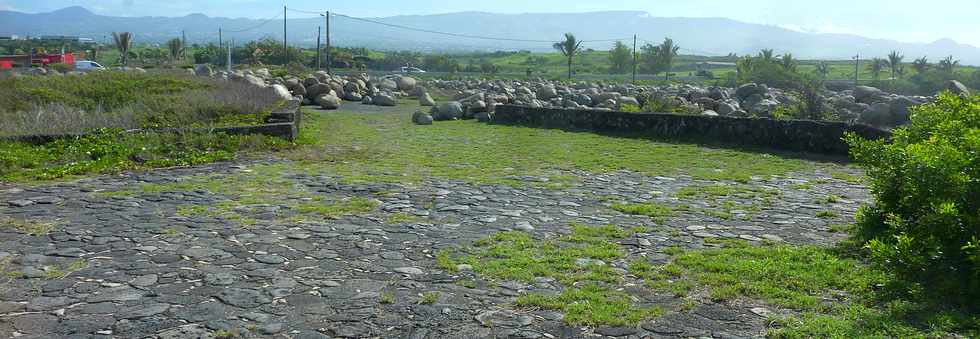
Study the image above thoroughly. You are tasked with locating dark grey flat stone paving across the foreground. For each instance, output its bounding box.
[0,158,868,338]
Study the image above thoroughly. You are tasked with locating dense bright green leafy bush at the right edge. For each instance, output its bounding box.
[846,93,980,307]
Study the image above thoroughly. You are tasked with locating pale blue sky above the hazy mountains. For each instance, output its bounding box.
[0,0,980,46]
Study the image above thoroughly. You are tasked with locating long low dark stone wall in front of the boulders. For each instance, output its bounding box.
[493,105,891,155]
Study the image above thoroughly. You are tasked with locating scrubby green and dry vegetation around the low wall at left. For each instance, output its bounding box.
[0,71,290,181]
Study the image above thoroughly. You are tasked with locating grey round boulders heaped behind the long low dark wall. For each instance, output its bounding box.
[419,79,969,127]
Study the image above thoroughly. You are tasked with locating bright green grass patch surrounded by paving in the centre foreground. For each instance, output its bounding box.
[436,225,662,326]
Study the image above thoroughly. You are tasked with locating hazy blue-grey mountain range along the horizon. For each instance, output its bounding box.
[0,7,980,65]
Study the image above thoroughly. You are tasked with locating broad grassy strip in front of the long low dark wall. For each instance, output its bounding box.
[289,102,828,186]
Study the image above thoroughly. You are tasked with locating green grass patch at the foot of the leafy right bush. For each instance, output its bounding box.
[646,241,980,338]
